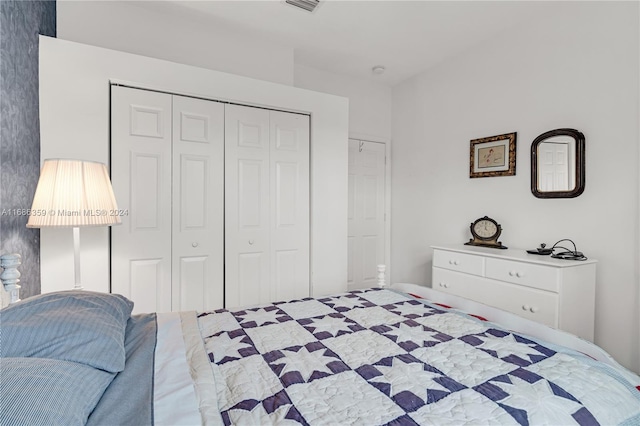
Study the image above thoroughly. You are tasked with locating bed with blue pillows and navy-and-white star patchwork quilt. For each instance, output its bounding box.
[0,284,640,425]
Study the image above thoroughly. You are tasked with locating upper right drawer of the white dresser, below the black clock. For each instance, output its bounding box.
[485,258,560,293]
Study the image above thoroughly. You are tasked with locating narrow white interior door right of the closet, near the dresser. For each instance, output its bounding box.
[347,139,385,290]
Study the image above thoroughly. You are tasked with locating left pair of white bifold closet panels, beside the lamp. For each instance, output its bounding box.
[111,87,224,312]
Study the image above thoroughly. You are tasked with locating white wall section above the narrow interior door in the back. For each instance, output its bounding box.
[293,64,391,142]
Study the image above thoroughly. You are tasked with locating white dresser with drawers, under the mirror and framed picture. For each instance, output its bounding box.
[432,244,596,341]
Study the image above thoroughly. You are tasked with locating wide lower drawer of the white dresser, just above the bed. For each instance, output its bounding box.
[432,268,559,327]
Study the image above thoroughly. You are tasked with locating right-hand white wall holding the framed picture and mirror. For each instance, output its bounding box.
[391,2,640,371]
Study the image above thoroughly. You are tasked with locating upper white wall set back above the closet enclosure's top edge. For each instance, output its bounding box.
[56,0,293,85]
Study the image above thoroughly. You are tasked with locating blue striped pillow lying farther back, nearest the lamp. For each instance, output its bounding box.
[0,290,133,373]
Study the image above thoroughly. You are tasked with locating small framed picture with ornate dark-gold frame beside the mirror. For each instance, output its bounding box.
[469,132,516,178]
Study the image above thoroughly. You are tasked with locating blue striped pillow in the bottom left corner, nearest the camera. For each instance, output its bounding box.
[0,358,114,426]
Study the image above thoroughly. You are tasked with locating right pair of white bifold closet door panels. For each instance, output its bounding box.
[225,105,310,308]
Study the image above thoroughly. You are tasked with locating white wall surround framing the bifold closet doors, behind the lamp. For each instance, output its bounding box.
[40,37,349,302]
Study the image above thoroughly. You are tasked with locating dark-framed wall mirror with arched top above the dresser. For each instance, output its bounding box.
[531,129,584,198]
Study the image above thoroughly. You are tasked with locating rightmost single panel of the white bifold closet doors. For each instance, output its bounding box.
[269,111,310,300]
